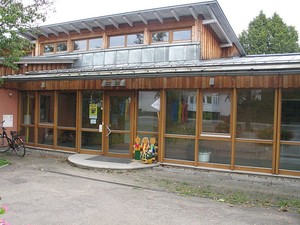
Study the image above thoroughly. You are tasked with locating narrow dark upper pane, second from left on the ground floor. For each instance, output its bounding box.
[39,92,54,124]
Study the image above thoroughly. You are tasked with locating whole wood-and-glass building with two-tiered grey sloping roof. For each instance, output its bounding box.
[0,1,300,176]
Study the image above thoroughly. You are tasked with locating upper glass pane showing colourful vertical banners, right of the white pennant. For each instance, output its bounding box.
[166,90,196,135]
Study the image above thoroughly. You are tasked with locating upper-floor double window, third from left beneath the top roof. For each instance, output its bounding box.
[109,33,144,48]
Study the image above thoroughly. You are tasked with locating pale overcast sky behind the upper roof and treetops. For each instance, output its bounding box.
[46,0,300,35]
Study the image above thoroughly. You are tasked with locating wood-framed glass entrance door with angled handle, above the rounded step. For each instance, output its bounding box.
[104,92,133,157]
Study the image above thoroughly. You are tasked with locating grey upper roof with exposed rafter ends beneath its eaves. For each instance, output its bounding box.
[20,0,245,55]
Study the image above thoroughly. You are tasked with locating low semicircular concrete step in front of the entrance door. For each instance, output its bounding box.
[68,154,159,170]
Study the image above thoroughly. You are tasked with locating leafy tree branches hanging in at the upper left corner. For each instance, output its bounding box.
[0,0,53,69]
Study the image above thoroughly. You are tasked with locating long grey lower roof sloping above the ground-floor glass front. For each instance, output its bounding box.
[4,54,300,81]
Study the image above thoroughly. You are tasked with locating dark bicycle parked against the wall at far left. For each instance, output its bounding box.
[0,121,26,157]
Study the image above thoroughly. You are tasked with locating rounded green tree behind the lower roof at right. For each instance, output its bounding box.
[239,11,300,55]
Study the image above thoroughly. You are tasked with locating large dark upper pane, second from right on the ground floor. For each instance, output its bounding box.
[237,89,274,140]
